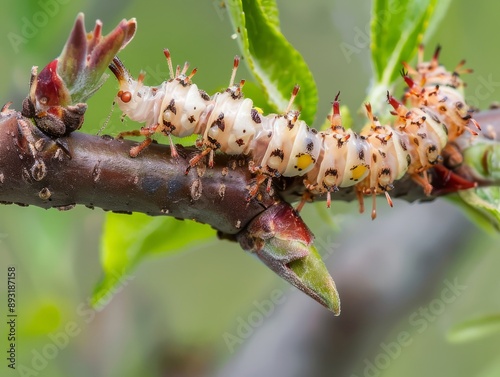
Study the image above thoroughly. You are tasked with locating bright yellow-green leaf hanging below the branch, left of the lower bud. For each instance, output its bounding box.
[92,213,214,306]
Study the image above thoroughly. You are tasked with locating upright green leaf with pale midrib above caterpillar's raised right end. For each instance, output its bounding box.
[367,0,450,113]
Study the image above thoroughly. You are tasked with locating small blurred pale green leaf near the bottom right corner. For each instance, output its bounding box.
[448,314,500,343]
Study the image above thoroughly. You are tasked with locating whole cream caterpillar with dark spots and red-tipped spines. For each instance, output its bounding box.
[110,46,479,218]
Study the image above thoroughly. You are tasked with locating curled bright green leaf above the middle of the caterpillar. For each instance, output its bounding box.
[227,0,318,124]
